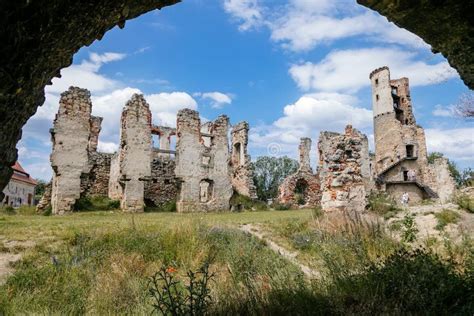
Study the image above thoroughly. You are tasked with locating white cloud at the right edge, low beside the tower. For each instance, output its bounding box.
[425,128,474,166]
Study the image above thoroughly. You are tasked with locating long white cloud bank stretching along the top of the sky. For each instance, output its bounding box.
[224,0,429,51]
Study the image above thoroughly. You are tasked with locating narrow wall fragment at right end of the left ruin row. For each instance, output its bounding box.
[231,122,257,199]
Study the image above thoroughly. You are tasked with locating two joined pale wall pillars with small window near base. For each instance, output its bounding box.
[175,109,233,212]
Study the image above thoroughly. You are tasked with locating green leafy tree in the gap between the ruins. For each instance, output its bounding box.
[252,156,298,201]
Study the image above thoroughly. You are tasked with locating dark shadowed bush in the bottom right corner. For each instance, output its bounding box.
[329,249,474,315]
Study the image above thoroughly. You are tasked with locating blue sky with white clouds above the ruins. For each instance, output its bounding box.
[18,0,474,180]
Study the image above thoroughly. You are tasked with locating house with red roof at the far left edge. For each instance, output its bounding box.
[0,161,37,207]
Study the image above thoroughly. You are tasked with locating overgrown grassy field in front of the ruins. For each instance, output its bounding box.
[0,210,474,315]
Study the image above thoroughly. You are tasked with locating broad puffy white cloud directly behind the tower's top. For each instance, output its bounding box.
[289,47,457,92]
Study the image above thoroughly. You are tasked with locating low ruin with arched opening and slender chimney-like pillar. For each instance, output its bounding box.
[278,138,321,207]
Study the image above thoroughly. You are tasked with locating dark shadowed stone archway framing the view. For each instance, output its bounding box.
[0,0,474,200]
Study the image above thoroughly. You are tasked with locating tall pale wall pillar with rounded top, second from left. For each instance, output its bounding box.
[118,94,152,212]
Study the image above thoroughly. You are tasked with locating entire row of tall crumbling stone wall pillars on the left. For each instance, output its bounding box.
[45,87,256,214]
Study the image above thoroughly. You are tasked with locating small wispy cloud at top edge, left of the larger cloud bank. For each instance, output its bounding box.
[224,0,263,31]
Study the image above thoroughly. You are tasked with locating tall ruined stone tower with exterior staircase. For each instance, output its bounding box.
[370,67,455,203]
